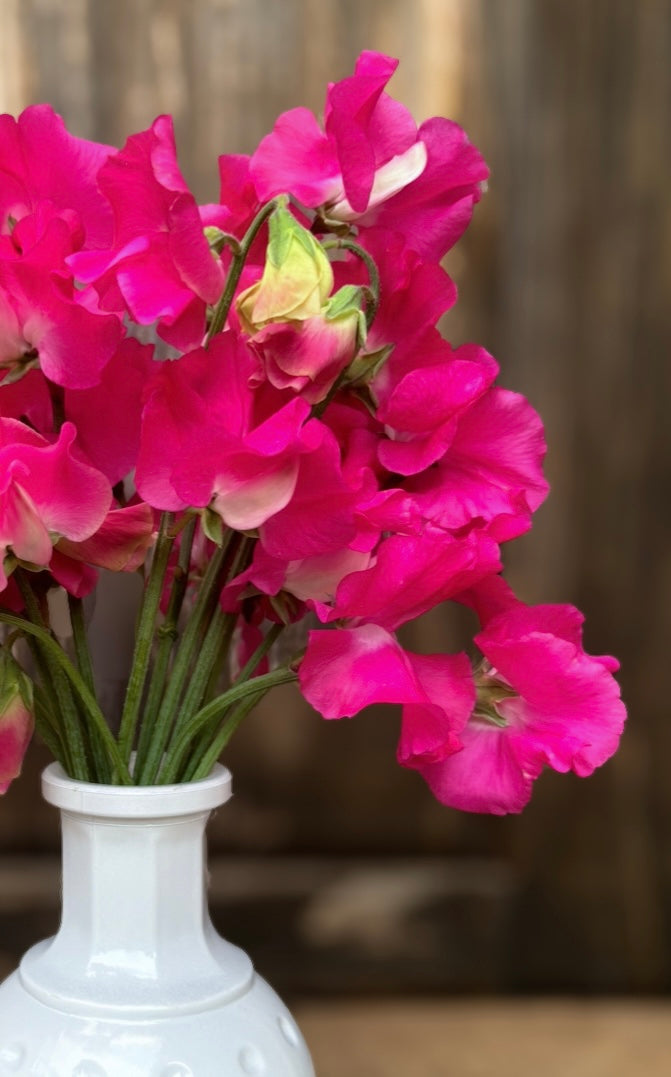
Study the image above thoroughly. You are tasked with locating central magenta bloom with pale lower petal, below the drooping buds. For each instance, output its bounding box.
[136,332,322,531]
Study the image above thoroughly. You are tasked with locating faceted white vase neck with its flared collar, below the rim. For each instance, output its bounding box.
[22,766,252,1017]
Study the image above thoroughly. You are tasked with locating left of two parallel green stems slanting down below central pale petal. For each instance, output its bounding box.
[136,539,232,785]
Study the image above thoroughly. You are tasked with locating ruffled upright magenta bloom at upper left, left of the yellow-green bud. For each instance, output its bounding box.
[70,116,224,350]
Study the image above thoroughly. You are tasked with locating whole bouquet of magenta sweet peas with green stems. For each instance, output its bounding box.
[0,53,625,814]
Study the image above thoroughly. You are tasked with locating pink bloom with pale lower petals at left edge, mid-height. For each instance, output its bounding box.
[0,419,112,590]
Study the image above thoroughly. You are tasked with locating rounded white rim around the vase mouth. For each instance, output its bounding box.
[42,763,232,820]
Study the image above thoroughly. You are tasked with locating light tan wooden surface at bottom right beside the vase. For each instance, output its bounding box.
[295,999,671,1077]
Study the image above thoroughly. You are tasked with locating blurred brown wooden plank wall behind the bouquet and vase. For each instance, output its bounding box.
[0,0,671,992]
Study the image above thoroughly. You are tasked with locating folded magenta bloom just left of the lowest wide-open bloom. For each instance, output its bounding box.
[298,625,475,767]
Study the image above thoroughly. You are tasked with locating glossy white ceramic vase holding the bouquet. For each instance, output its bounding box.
[0,764,314,1077]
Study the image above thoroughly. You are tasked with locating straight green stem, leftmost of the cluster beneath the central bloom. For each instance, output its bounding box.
[118,513,174,765]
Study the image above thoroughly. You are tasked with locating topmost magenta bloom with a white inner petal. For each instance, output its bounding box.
[250,52,488,261]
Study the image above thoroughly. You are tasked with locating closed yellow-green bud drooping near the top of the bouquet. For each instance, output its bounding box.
[237,206,333,336]
